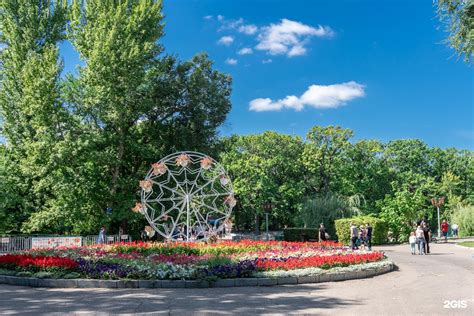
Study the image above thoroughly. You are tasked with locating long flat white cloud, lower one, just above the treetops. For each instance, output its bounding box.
[249,81,365,112]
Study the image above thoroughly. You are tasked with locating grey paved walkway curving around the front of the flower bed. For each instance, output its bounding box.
[0,243,474,315]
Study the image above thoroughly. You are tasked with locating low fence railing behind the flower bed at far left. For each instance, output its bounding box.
[0,234,132,253]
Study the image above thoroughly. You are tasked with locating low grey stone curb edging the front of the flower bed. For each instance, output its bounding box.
[0,260,395,289]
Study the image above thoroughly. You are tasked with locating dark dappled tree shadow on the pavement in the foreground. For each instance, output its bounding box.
[0,284,361,315]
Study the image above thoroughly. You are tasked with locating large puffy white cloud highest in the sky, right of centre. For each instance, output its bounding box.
[255,19,334,57]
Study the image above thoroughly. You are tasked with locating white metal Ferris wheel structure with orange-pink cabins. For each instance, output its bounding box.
[133,151,236,241]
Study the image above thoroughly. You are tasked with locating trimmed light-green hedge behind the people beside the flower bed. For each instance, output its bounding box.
[335,216,388,245]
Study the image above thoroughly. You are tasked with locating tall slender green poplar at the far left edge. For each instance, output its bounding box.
[0,0,68,229]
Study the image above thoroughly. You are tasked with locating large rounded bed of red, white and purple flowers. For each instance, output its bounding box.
[0,241,385,280]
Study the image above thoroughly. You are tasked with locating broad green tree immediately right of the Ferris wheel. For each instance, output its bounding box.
[220,132,305,228]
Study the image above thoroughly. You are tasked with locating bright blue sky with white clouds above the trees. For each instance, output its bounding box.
[62,0,474,150]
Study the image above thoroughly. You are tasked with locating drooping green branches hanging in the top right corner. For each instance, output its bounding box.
[435,0,474,62]
